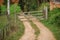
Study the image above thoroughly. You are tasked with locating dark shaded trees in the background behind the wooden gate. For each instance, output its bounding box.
[19,0,49,11]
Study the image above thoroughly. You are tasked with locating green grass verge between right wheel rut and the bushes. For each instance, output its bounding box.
[42,21,60,40]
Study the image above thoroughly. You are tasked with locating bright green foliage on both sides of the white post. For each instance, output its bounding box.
[1,4,21,15]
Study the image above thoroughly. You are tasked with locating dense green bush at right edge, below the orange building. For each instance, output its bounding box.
[49,8,60,26]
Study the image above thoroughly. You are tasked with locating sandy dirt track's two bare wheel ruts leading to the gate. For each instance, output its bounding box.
[19,16,56,40]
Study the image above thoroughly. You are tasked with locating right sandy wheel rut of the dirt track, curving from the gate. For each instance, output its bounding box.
[30,17,56,40]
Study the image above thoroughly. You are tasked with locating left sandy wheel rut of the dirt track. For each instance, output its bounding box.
[19,16,35,40]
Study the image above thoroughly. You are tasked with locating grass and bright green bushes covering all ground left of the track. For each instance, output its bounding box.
[0,4,25,40]
